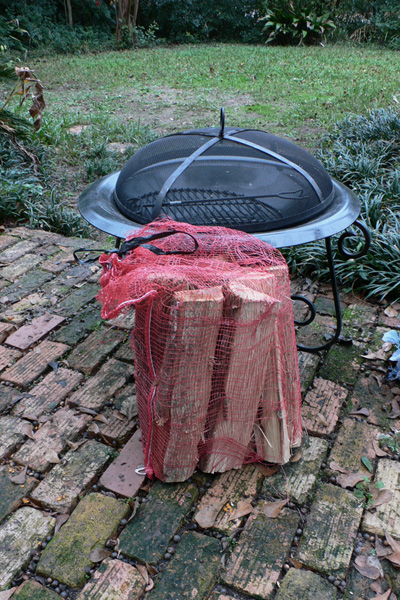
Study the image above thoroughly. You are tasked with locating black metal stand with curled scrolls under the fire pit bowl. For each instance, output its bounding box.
[292,221,371,352]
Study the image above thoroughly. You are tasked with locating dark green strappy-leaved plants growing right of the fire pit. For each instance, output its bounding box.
[285,109,400,298]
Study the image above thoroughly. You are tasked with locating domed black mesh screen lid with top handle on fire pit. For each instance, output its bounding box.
[114,109,335,233]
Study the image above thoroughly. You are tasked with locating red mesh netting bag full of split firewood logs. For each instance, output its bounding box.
[98,219,301,481]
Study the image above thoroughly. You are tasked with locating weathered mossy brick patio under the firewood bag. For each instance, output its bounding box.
[0,227,400,600]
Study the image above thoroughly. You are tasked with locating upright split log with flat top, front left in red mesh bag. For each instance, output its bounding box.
[163,286,224,482]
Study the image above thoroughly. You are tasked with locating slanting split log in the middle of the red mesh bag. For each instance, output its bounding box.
[200,274,279,473]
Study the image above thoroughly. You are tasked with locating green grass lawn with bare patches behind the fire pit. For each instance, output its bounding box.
[15,44,400,205]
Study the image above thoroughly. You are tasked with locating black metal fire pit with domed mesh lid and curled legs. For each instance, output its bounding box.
[79,109,370,352]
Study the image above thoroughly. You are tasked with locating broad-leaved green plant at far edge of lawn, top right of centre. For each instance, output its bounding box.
[261,0,335,44]
